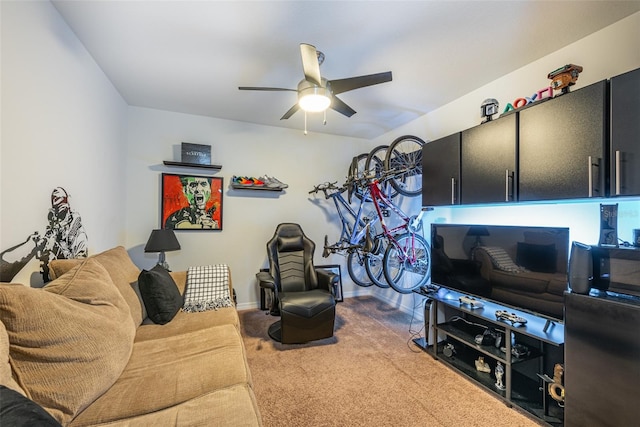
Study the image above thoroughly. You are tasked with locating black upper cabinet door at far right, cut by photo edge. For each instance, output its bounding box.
[609,68,640,196]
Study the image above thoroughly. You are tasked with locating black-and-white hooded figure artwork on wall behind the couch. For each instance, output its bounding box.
[0,187,88,282]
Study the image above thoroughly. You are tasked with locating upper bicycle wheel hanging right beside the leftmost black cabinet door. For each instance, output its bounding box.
[384,135,425,197]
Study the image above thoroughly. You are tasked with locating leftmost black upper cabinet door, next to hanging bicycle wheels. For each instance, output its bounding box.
[422,132,460,206]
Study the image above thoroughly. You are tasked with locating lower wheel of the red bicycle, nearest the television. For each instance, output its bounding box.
[383,233,431,294]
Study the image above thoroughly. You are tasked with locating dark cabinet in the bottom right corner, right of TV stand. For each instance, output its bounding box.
[564,293,640,427]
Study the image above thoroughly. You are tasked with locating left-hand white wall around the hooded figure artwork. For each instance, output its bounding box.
[0,1,127,285]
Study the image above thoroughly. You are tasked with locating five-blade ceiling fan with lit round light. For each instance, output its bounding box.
[238,43,391,123]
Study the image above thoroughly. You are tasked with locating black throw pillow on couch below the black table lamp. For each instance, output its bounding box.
[138,265,183,325]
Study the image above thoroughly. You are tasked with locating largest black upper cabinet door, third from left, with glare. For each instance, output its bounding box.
[518,80,608,201]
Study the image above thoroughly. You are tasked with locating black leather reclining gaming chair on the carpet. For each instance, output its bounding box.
[256,223,339,344]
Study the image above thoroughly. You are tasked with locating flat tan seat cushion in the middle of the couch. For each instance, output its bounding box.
[68,324,251,425]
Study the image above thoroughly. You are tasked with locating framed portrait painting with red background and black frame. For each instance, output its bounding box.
[161,173,222,230]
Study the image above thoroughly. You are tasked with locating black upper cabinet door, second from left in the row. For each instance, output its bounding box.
[460,113,518,204]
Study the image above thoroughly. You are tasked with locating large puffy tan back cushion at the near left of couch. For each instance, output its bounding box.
[0,259,135,424]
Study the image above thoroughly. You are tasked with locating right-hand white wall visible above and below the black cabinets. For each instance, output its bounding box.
[364,13,640,311]
